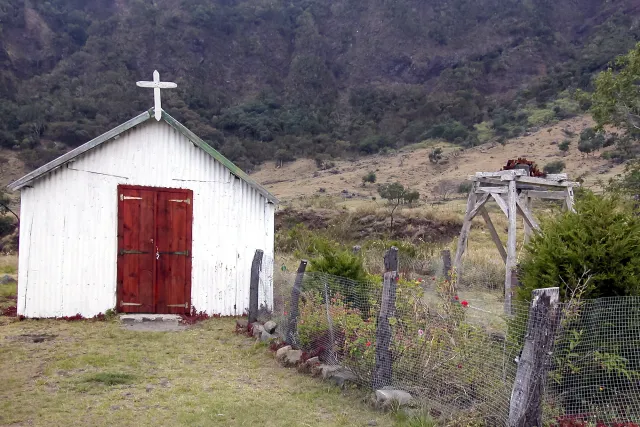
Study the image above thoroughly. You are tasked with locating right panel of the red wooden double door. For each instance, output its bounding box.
[155,191,192,313]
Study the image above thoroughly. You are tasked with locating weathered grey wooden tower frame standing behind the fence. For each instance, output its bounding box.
[454,168,580,314]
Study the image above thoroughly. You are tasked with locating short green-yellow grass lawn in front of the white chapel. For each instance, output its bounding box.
[0,317,398,427]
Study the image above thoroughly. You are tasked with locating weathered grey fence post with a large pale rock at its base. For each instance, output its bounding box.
[371,247,398,389]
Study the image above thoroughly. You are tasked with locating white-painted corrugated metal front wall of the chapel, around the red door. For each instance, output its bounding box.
[18,121,275,317]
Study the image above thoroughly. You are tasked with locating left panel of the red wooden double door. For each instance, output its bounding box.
[117,188,155,313]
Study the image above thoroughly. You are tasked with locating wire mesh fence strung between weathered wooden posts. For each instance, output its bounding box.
[272,270,640,425]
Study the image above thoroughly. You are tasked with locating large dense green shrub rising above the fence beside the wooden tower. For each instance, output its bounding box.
[518,191,640,300]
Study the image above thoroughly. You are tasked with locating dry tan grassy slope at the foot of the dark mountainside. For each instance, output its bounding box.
[252,116,622,206]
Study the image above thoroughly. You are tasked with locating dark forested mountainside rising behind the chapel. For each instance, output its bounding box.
[0,0,640,170]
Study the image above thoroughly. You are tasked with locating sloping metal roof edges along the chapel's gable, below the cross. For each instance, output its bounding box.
[7,108,278,204]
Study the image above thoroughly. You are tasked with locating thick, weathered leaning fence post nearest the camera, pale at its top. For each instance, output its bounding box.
[508,288,560,427]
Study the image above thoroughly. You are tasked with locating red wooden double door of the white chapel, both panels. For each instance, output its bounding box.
[117,186,193,314]
